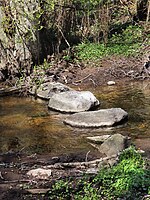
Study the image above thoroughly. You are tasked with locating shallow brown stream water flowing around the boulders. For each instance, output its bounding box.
[0,82,150,155]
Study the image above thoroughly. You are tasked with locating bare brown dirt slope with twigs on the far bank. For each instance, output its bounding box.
[44,56,150,88]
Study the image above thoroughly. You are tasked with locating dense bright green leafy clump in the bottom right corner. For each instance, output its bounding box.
[95,147,150,200]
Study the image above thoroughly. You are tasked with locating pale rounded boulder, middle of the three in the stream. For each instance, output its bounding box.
[48,91,99,113]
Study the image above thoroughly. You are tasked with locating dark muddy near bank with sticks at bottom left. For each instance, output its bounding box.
[0,152,102,200]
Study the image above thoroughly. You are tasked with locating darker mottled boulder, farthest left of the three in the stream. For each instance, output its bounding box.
[30,82,73,100]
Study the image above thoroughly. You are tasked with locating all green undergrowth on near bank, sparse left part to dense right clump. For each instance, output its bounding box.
[49,147,150,200]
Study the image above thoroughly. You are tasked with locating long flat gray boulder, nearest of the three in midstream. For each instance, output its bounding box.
[64,108,128,128]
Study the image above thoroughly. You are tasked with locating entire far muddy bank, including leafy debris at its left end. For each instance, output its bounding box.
[0,53,150,91]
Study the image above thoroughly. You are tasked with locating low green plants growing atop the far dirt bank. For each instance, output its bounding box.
[76,26,146,61]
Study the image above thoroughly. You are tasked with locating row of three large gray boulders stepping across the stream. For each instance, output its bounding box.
[30,82,128,128]
